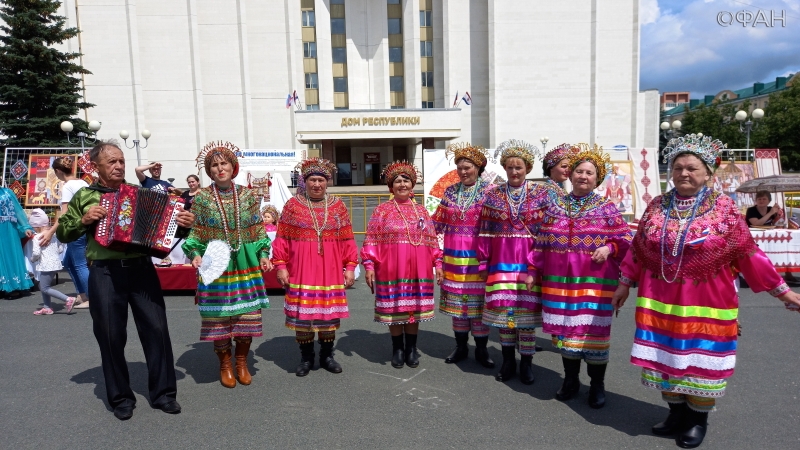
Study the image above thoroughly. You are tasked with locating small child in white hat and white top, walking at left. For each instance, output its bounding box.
[28,208,76,316]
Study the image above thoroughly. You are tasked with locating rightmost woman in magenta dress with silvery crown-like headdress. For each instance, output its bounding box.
[612,134,800,448]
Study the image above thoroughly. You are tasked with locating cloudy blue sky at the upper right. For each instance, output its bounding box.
[639,0,800,98]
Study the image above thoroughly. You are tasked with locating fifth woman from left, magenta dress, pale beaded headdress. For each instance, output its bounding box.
[477,139,552,384]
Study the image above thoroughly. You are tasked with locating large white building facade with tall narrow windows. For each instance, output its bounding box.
[54,0,659,186]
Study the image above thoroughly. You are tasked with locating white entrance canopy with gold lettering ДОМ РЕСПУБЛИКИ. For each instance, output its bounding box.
[294,109,461,144]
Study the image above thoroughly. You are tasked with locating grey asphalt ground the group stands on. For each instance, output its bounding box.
[0,277,800,449]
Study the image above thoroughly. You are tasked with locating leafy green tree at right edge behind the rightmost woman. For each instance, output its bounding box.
[754,81,800,170]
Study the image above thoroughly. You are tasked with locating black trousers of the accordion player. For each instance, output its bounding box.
[89,258,177,408]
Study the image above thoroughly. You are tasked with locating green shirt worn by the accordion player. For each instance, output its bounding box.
[56,183,147,261]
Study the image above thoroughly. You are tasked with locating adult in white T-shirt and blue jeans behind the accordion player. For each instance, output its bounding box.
[39,157,89,309]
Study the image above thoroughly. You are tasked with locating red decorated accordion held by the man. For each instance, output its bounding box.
[94,184,183,258]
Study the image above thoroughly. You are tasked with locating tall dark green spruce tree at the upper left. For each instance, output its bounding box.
[0,0,94,147]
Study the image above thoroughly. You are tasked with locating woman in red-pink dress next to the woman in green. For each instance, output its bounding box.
[272,158,358,377]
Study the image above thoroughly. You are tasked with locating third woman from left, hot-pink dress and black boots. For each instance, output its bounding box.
[361,161,443,369]
